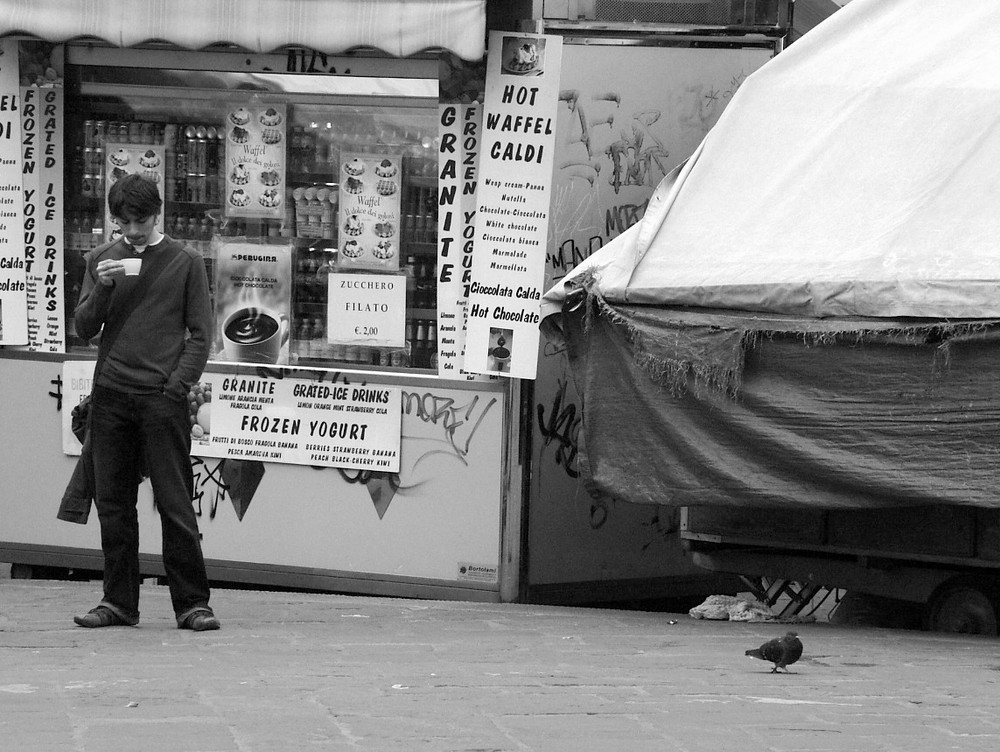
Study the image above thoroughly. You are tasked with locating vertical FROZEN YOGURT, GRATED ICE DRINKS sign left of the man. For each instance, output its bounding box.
[21,85,66,353]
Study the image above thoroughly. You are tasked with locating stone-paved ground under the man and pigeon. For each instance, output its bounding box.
[0,579,1000,752]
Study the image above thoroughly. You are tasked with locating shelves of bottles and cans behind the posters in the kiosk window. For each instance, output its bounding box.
[65,117,437,371]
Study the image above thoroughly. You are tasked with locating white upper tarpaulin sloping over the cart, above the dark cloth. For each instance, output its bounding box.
[543,0,1000,318]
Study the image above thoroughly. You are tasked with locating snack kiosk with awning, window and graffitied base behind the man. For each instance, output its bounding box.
[0,0,520,600]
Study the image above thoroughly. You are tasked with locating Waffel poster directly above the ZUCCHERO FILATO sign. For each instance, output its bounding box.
[337,153,401,271]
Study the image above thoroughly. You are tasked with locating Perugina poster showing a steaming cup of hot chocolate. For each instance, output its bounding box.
[212,243,292,364]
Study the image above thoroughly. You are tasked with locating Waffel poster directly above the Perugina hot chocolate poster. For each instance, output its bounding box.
[223,103,287,219]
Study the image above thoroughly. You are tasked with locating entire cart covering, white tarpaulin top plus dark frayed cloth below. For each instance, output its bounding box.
[543,0,1000,509]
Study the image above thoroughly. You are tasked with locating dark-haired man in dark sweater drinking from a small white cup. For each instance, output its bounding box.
[73,175,219,631]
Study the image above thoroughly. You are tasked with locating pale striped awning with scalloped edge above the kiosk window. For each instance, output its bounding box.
[0,0,486,60]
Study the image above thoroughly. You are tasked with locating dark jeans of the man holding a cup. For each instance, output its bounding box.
[90,387,209,617]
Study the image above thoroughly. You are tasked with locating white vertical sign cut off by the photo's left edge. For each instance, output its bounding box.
[0,37,28,345]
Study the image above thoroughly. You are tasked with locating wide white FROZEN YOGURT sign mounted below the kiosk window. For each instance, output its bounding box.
[191,373,402,472]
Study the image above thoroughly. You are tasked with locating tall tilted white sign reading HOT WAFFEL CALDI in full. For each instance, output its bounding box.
[463,32,562,379]
